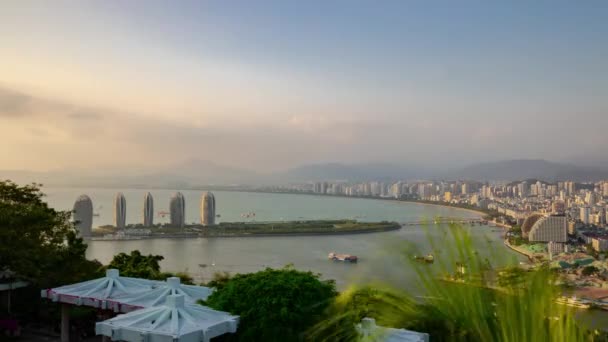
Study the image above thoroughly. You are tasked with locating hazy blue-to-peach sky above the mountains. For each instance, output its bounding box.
[0,0,608,171]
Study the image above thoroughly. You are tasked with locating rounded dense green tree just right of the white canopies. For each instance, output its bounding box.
[204,267,337,341]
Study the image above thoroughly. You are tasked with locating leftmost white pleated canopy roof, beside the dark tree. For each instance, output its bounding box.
[41,269,163,312]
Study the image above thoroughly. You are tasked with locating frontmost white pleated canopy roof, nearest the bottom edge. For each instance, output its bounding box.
[95,295,238,342]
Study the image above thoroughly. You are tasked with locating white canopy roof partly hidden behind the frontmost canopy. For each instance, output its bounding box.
[120,277,213,308]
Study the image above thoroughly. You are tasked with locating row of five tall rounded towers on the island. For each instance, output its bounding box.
[73,192,215,236]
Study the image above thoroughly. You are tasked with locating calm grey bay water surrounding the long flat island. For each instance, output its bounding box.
[43,188,519,289]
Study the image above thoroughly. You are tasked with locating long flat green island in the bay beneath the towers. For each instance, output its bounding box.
[92,220,401,240]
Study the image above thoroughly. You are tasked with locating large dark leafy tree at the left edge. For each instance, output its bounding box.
[0,181,101,288]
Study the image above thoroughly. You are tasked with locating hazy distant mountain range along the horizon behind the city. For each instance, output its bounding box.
[0,159,608,189]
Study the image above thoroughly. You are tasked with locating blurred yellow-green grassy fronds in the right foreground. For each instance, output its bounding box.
[307,226,595,342]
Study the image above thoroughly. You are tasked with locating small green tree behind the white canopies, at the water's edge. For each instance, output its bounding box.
[108,250,194,284]
